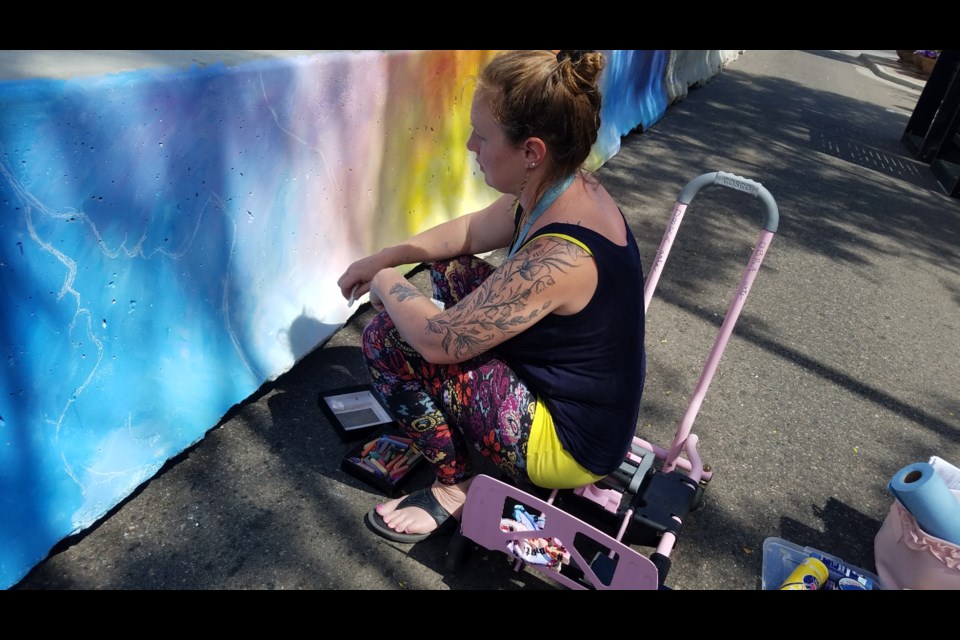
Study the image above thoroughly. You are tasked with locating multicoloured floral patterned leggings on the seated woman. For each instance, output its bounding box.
[361,256,536,484]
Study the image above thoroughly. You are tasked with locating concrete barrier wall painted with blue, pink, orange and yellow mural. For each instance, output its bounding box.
[0,51,738,589]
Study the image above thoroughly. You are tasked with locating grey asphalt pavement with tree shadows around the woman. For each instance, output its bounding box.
[13,50,960,591]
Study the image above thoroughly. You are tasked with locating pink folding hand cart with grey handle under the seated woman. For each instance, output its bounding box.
[445,171,779,590]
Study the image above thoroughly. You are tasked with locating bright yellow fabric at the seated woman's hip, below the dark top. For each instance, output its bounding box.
[527,398,604,489]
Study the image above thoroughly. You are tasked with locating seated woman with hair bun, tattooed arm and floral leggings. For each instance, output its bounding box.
[338,51,645,542]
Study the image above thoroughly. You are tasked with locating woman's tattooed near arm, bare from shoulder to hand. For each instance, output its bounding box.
[371,236,597,364]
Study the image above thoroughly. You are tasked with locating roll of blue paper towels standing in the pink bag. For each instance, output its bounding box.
[888,462,960,544]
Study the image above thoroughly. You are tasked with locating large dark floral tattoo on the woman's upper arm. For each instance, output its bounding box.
[420,237,589,359]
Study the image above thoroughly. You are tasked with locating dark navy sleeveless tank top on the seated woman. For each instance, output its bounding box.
[497,220,646,475]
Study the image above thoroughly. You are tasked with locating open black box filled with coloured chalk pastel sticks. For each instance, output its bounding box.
[340,425,423,498]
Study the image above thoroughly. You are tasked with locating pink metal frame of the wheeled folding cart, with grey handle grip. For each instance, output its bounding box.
[458,171,779,589]
